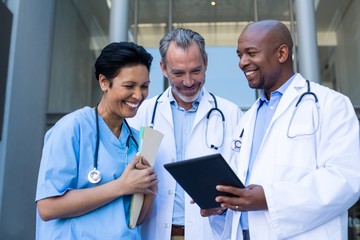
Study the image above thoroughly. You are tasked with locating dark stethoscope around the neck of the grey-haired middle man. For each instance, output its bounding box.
[150,93,225,150]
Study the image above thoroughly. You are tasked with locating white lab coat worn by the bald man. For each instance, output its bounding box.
[214,74,360,240]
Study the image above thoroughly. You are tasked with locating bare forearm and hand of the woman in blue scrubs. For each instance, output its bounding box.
[37,155,158,221]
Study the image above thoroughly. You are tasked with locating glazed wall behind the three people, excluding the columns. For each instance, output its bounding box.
[49,0,360,112]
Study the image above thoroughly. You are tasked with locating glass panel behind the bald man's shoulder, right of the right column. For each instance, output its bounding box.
[316,0,360,107]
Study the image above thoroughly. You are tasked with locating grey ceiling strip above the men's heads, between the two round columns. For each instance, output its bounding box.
[139,0,289,23]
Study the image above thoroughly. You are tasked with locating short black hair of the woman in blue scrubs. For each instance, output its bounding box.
[95,42,153,82]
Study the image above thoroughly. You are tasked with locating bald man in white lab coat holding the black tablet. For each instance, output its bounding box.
[205,20,360,240]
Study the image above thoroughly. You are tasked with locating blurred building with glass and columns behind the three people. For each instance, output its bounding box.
[0,0,360,240]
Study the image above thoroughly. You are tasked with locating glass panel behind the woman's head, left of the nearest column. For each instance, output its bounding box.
[47,0,109,127]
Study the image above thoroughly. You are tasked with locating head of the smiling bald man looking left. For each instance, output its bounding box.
[237,22,292,96]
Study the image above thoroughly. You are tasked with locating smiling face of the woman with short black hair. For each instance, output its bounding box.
[99,64,150,125]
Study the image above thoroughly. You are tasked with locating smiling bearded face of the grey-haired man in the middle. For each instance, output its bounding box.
[160,42,207,109]
